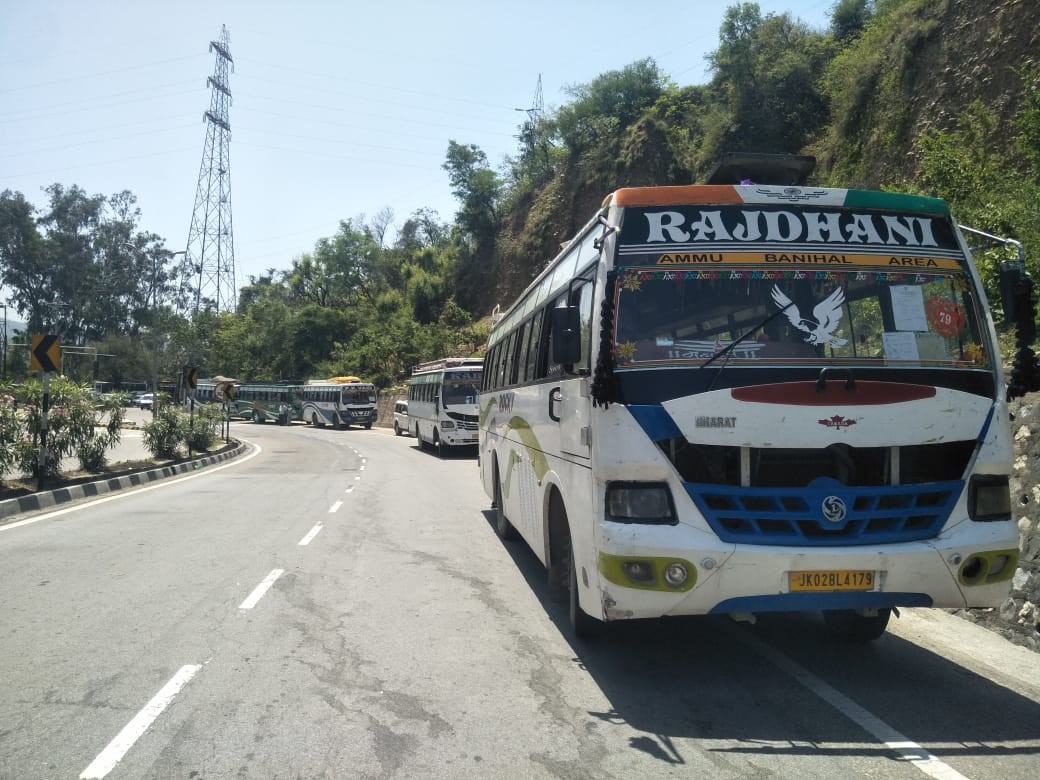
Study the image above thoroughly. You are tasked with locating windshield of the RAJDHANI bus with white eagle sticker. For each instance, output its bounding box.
[615,265,991,370]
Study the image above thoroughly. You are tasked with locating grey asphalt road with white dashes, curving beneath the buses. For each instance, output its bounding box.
[0,423,1040,779]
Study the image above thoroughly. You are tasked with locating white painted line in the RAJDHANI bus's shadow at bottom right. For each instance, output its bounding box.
[736,631,968,780]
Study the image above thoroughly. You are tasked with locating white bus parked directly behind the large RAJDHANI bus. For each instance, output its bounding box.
[408,358,484,458]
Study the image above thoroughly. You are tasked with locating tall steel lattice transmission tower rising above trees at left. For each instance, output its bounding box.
[181,26,238,314]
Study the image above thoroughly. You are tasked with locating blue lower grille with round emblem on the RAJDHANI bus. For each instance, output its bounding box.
[684,477,964,547]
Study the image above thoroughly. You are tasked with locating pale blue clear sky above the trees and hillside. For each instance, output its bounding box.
[0,0,836,287]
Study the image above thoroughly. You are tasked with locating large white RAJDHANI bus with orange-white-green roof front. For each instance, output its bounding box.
[479,155,1018,642]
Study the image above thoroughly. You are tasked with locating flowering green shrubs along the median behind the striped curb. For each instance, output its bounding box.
[0,376,220,478]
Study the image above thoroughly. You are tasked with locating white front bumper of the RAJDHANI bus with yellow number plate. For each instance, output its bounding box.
[582,520,1018,620]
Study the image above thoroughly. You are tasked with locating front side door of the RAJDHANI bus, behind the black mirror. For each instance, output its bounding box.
[549,280,594,458]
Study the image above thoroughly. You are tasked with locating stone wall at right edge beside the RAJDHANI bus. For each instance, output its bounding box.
[963,393,1040,652]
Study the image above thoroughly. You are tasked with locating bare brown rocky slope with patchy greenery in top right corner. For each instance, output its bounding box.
[805,0,1040,187]
